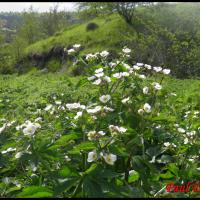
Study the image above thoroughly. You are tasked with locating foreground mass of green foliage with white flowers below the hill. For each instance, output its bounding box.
[0,44,200,198]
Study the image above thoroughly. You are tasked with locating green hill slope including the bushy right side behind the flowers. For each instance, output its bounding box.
[16,4,200,78]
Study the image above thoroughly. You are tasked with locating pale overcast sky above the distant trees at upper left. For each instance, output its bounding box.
[0,2,75,12]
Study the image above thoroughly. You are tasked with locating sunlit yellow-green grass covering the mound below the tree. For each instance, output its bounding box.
[26,15,135,54]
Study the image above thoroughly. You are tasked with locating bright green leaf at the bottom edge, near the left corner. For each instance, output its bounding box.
[17,186,53,198]
